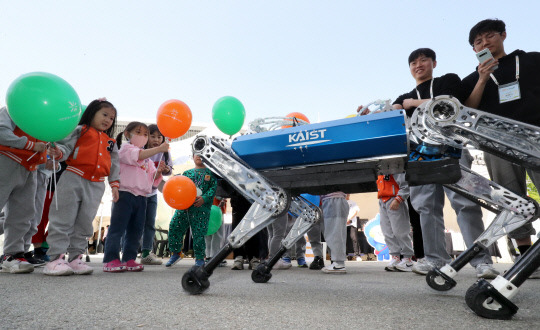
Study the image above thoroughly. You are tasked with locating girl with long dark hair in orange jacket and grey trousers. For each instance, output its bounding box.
[43,99,120,275]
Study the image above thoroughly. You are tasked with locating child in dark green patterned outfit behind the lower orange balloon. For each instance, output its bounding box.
[165,156,217,267]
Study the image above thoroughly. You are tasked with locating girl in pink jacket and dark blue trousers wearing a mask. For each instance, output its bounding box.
[103,121,169,272]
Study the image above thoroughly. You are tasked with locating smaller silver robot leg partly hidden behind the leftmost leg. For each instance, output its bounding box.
[251,196,322,283]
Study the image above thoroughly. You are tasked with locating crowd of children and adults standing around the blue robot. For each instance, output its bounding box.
[0,19,540,279]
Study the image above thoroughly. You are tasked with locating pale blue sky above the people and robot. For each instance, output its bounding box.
[0,0,540,123]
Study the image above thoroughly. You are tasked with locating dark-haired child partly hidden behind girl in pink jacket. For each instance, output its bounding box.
[141,124,172,265]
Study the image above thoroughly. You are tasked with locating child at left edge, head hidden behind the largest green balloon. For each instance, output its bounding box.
[0,107,47,273]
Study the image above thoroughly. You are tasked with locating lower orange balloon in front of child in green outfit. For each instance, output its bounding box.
[163,175,197,210]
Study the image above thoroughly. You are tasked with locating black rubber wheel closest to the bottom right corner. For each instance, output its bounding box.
[465,281,517,320]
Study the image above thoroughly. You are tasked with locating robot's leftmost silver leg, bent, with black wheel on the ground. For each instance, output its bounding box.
[182,136,290,294]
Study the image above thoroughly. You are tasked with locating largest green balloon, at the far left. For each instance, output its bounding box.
[6,72,82,142]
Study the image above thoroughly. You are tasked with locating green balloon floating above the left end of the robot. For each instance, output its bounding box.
[212,96,246,135]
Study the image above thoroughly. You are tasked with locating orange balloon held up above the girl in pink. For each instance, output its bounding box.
[157,100,192,139]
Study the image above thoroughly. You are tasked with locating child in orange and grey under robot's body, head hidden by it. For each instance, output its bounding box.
[377,173,414,272]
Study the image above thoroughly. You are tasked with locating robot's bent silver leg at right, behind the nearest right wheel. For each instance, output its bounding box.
[426,167,538,291]
